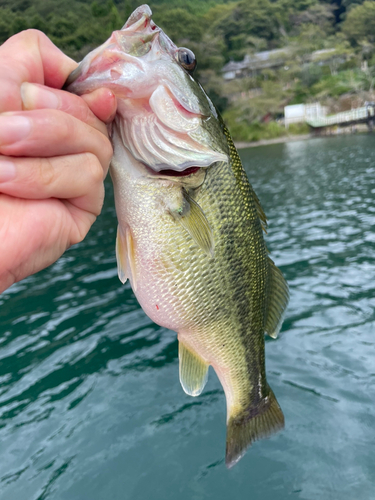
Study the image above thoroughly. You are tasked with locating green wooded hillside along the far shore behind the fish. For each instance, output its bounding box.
[0,0,375,143]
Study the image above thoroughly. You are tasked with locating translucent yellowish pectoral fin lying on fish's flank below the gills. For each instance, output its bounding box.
[175,191,214,257]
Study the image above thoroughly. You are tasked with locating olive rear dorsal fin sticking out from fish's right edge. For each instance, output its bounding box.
[265,258,289,339]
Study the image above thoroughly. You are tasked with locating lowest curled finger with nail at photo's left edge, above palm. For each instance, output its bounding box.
[0,153,104,215]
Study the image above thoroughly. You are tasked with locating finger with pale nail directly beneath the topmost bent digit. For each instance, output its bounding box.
[21,82,109,135]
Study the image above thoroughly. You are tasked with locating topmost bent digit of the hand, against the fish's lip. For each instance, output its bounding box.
[0,30,77,113]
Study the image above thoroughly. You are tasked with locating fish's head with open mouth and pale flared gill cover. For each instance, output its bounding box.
[65,5,228,174]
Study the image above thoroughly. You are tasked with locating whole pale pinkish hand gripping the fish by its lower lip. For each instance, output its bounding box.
[0,30,116,293]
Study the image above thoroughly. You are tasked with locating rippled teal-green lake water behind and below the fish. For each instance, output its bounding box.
[0,135,375,500]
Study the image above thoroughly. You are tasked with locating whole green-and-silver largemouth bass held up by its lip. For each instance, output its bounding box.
[66,5,288,467]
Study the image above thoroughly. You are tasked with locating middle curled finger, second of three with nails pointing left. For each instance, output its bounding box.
[0,109,112,173]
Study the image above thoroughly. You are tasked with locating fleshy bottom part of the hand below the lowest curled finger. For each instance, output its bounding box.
[0,194,96,293]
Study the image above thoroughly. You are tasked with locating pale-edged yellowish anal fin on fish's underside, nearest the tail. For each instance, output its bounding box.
[178,340,209,396]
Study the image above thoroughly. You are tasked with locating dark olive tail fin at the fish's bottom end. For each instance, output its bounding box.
[225,389,284,469]
